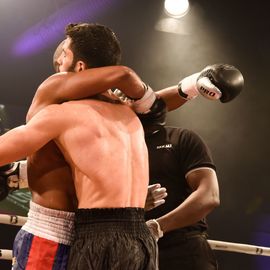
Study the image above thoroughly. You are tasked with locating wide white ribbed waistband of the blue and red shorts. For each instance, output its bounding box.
[22,201,75,245]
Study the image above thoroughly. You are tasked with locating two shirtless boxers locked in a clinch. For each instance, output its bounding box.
[0,21,245,270]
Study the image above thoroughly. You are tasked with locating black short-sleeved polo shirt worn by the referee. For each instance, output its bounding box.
[146,127,215,231]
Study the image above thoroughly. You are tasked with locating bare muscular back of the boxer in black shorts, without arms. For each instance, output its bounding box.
[53,100,148,208]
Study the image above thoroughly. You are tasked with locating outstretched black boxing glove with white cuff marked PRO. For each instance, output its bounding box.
[178,64,244,103]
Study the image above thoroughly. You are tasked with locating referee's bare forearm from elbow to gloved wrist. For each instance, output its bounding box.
[157,190,219,233]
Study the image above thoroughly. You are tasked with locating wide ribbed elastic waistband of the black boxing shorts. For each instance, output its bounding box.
[75,207,149,236]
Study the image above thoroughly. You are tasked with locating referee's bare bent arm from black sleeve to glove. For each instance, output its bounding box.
[157,168,219,233]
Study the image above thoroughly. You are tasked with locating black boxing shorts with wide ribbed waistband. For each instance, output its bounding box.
[68,208,158,270]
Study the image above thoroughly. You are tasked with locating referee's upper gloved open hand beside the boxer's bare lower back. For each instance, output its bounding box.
[144,184,168,211]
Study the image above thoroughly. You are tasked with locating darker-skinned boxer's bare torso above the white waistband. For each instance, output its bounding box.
[28,142,77,211]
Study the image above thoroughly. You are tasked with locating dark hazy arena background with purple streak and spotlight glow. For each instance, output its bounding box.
[0,0,270,270]
